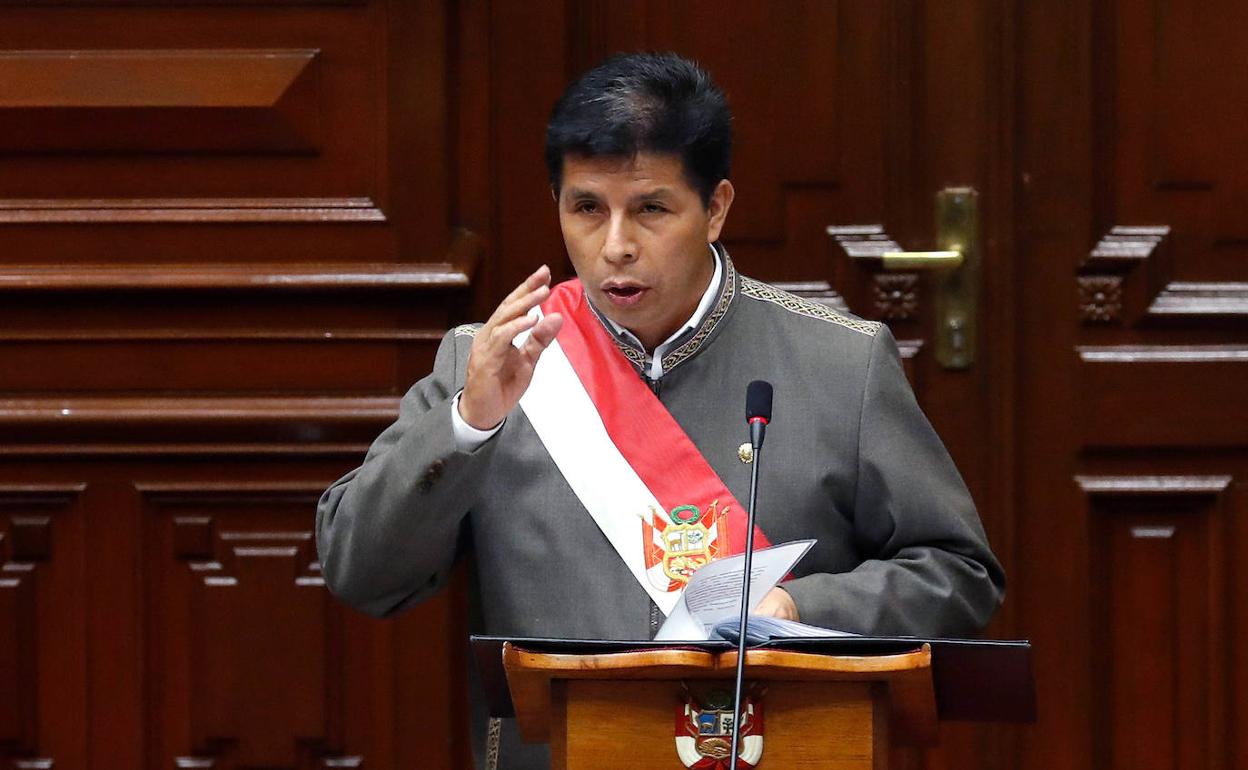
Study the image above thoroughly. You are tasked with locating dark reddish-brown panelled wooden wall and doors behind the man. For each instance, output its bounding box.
[0,0,1248,770]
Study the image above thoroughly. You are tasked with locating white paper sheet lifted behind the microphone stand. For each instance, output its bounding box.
[655,540,815,641]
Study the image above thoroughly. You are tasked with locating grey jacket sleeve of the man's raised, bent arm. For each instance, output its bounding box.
[316,329,497,616]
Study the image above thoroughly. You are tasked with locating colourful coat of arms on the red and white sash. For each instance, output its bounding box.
[641,500,729,592]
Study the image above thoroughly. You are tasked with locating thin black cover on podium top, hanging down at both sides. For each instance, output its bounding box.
[470,636,1036,723]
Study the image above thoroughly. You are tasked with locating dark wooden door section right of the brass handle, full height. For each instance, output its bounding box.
[1013,0,1248,769]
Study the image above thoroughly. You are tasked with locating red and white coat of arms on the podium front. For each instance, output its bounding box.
[676,689,763,770]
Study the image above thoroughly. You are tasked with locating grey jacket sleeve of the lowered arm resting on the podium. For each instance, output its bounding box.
[784,327,1005,636]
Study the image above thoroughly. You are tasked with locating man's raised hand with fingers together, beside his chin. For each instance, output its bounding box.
[459,265,563,431]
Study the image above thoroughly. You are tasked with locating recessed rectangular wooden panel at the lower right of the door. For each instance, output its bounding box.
[1076,475,1238,768]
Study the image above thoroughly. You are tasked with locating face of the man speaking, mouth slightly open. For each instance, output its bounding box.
[558,152,733,349]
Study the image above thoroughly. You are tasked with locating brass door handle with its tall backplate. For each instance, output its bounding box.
[827,187,981,369]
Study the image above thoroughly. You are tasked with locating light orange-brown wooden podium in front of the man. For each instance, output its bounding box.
[502,643,937,770]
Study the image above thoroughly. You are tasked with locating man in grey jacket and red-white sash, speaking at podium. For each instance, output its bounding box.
[317,54,1003,763]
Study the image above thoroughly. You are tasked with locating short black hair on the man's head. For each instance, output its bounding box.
[545,54,733,205]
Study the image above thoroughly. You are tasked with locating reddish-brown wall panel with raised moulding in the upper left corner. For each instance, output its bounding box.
[0,0,461,265]
